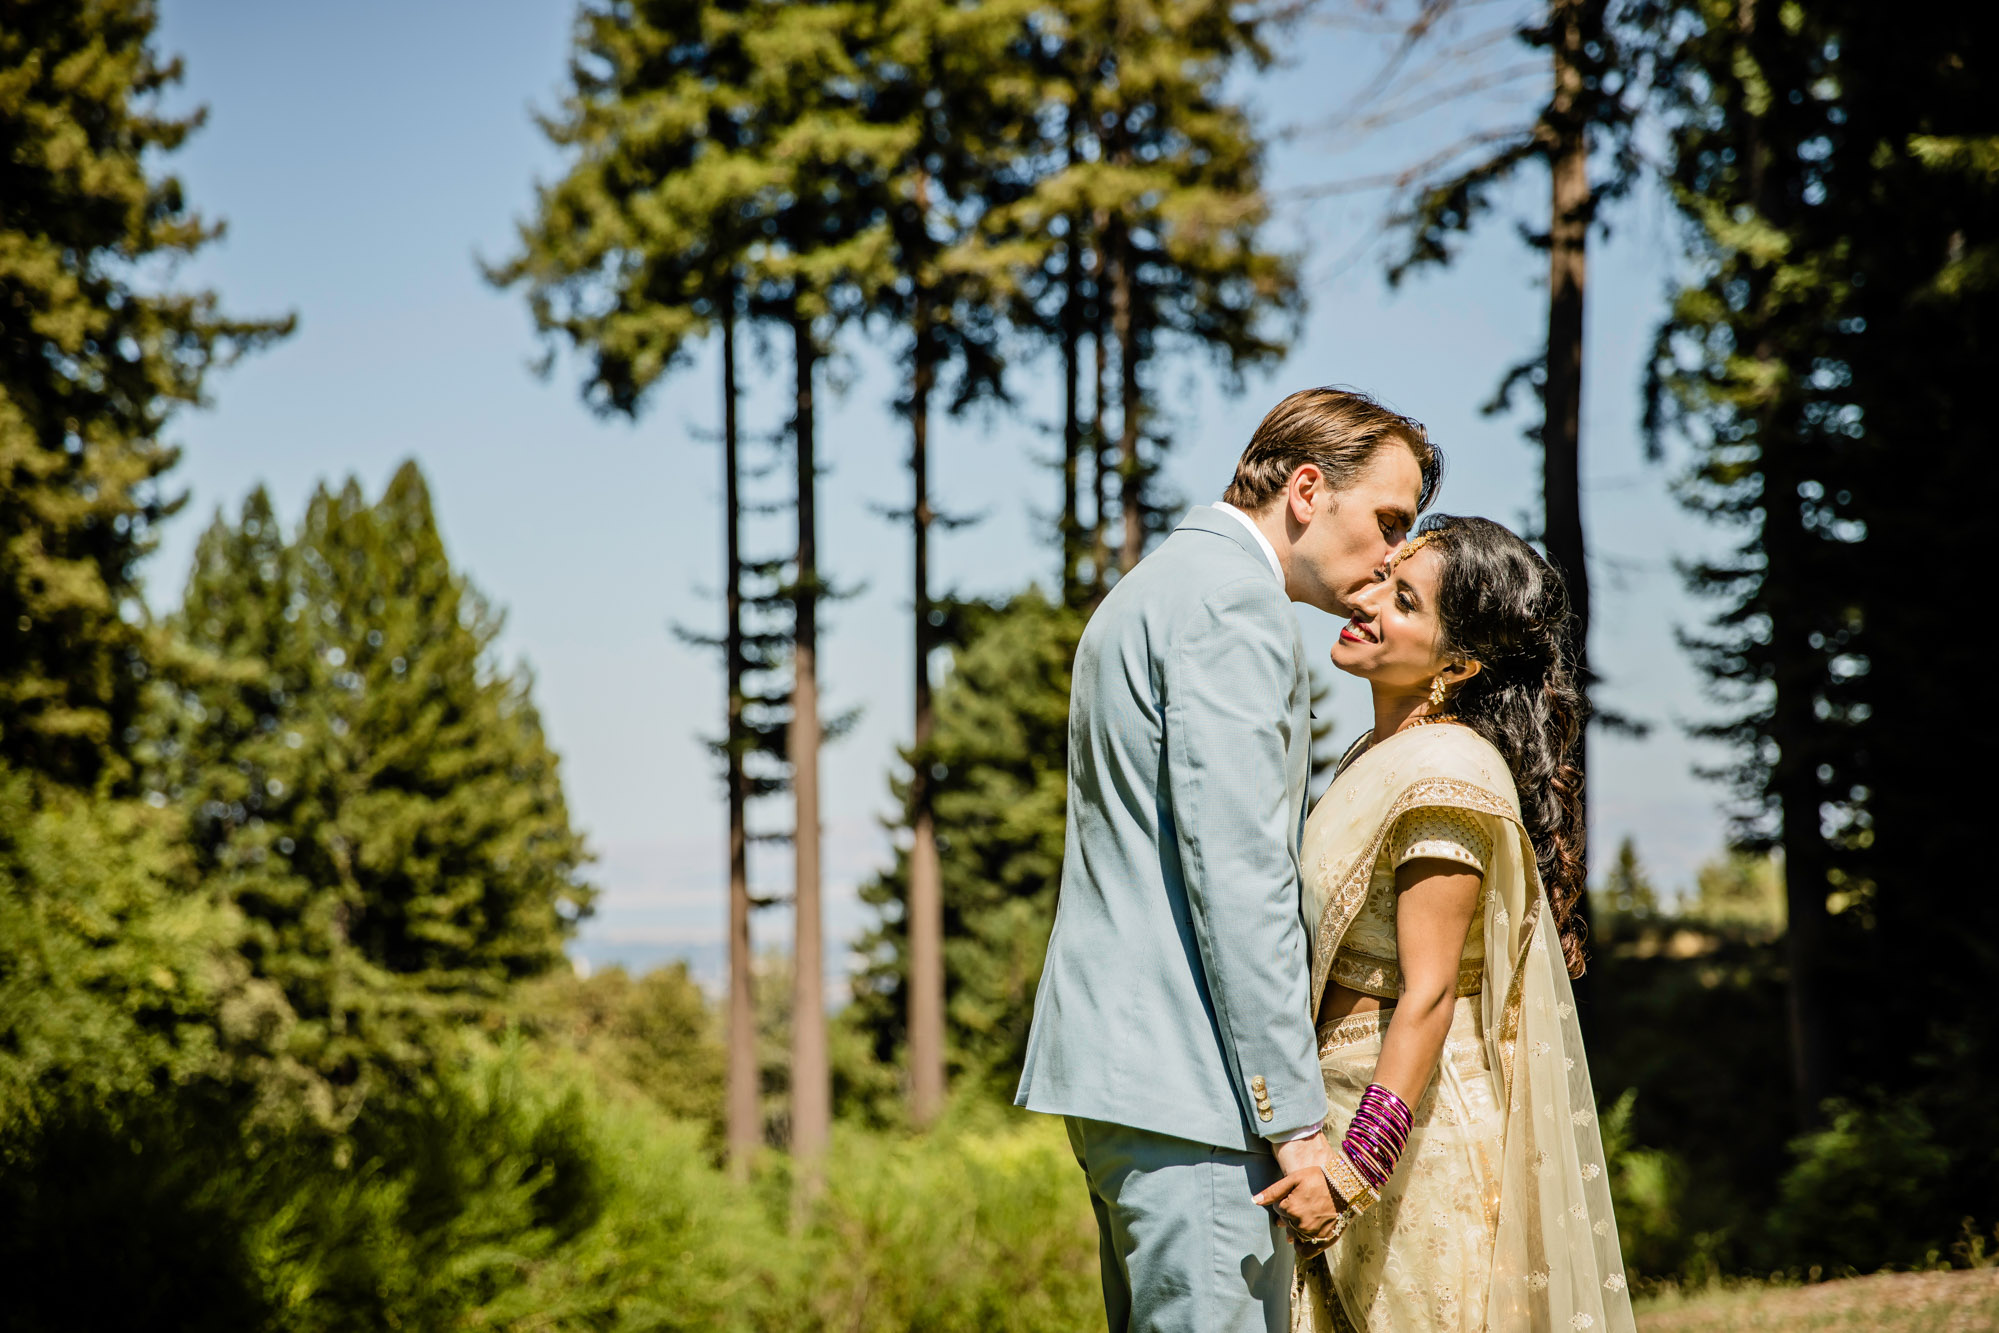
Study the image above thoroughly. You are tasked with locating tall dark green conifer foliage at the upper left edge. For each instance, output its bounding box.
[0,0,292,787]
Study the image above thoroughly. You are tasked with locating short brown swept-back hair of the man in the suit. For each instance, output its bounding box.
[1221,388,1443,514]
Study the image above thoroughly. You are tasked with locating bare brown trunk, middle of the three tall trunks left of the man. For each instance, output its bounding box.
[790,316,834,1193]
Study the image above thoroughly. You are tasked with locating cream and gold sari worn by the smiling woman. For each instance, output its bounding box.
[1291,723,1635,1333]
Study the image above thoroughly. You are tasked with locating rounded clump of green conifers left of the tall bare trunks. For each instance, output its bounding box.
[146,464,592,1121]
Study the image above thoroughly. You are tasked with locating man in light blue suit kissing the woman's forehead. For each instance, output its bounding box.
[1013,390,1439,1333]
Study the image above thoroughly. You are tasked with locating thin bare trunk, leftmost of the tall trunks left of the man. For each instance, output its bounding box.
[722,292,764,1179]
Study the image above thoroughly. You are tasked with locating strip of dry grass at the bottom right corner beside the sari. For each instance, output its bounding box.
[1637,1267,1999,1333]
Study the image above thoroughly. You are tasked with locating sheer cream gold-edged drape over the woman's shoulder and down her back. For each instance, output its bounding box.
[1305,725,1635,1333]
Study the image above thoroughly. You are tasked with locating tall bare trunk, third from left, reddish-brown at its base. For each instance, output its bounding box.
[908,292,944,1127]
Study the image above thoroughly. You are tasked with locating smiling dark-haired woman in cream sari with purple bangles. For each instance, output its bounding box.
[1263,516,1633,1333]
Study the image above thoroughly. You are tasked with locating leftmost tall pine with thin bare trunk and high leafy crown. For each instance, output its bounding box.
[488,2,788,1171]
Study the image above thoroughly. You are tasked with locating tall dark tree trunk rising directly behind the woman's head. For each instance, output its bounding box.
[1541,0,1603,991]
